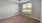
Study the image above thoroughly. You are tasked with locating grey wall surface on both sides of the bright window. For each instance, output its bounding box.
[19,0,41,19]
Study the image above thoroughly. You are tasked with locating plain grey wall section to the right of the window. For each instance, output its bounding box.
[32,0,41,19]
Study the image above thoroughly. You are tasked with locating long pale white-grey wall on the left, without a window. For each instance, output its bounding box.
[0,0,19,19]
